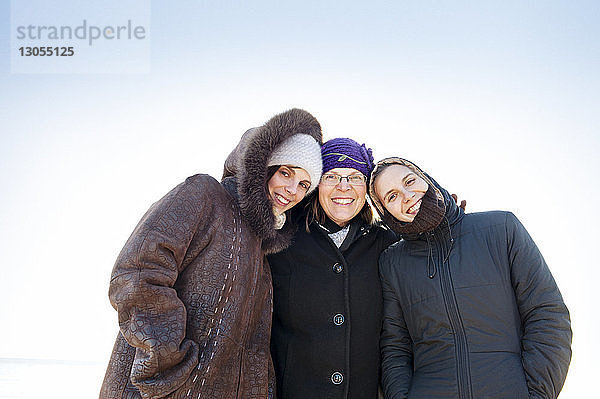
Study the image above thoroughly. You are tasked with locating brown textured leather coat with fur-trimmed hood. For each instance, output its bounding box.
[100,110,321,399]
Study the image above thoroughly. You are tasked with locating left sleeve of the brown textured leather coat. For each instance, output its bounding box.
[109,177,218,398]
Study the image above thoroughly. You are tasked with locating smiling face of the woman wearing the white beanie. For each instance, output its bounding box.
[267,165,311,215]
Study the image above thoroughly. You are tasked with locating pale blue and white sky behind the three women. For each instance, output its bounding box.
[0,1,600,399]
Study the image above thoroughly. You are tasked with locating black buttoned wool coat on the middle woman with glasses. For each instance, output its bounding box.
[268,214,396,399]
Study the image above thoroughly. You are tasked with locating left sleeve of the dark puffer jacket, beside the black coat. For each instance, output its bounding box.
[379,250,413,399]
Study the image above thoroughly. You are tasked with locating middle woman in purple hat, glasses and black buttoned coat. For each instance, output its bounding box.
[268,138,395,399]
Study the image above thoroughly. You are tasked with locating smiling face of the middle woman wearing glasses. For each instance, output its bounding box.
[319,168,367,226]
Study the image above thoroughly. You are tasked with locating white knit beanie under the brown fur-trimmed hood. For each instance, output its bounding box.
[267,134,323,194]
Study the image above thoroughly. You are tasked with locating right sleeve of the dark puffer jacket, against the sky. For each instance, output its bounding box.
[506,213,572,398]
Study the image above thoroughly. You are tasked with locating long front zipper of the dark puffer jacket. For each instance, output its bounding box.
[435,231,472,399]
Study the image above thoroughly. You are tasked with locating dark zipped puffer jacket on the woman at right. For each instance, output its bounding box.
[380,183,571,399]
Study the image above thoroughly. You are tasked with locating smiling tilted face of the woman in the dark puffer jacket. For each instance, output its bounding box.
[374,165,429,223]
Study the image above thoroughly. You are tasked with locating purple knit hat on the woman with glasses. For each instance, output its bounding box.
[321,137,375,179]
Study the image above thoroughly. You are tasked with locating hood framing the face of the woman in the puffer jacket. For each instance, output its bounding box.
[369,157,464,239]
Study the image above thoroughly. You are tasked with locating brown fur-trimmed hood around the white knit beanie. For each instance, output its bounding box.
[223,108,323,254]
